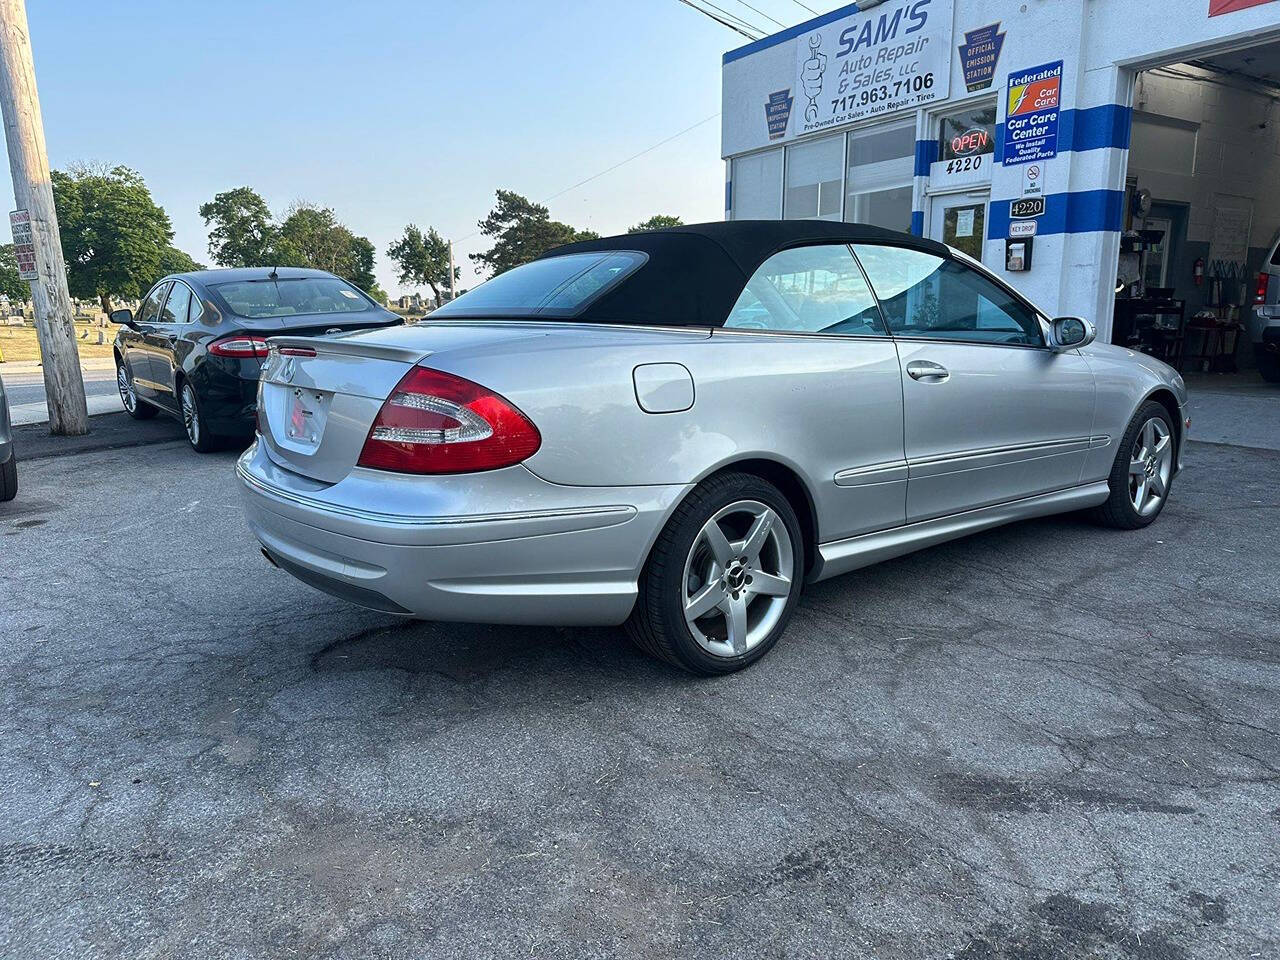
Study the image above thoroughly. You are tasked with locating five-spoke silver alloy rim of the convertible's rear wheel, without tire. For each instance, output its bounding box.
[681,500,795,657]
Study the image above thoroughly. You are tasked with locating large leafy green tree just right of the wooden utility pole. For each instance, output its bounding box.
[52,166,190,314]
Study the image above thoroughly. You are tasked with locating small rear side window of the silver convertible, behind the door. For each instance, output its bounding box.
[724,244,884,337]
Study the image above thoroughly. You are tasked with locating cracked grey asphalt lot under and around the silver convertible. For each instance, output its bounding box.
[0,417,1280,960]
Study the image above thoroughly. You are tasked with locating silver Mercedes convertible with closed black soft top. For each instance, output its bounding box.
[237,221,1190,673]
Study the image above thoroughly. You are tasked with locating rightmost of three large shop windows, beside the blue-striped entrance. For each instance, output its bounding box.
[845,122,915,233]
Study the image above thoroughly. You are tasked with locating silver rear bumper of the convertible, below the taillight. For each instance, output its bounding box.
[237,443,687,626]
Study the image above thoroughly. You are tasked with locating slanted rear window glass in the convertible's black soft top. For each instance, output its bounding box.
[431,250,649,320]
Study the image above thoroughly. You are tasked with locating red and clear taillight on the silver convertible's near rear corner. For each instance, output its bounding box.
[360,366,543,474]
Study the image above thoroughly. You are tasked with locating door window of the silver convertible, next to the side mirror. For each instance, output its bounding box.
[854,244,1044,347]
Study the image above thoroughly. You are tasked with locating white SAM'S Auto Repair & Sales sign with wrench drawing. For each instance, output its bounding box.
[788,0,954,136]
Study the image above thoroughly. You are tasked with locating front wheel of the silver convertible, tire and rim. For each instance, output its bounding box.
[1093,401,1178,530]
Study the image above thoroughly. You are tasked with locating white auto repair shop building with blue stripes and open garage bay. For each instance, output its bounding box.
[722,0,1280,369]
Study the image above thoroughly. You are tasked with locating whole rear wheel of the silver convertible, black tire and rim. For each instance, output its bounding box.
[627,474,804,676]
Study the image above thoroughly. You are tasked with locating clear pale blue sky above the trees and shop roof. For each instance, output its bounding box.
[0,0,841,292]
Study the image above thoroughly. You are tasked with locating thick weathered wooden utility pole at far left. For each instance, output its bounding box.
[0,0,88,436]
